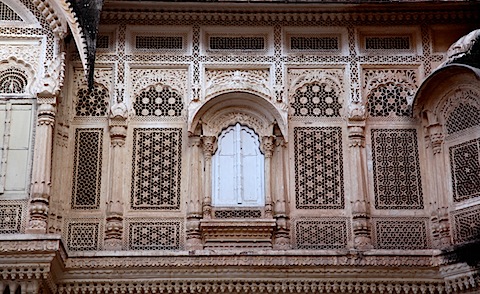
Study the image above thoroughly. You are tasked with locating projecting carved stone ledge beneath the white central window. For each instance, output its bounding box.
[200,219,276,249]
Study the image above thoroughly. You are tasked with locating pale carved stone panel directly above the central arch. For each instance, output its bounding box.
[205,69,272,100]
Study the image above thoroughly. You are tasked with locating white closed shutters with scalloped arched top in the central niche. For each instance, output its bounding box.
[212,123,265,207]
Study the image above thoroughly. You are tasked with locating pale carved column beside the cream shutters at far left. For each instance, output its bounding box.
[26,94,56,234]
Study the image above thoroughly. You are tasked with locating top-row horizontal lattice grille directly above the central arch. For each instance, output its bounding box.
[209,36,265,50]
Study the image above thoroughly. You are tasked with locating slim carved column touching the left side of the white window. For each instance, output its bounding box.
[202,136,217,219]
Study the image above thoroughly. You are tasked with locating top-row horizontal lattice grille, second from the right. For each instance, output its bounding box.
[290,36,339,51]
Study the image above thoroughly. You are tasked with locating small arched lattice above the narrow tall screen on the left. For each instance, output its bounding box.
[75,85,109,116]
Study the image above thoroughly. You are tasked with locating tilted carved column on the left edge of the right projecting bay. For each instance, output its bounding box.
[425,112,451,248]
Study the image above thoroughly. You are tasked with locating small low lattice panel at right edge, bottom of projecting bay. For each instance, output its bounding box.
[452,205,480,243]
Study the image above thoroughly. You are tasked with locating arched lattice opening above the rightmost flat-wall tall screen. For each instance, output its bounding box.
[368,83,412,117]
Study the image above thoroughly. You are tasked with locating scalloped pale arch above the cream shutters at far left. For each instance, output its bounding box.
[0,56,36,96]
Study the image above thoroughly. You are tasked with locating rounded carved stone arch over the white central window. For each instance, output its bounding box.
[188,92,288,140]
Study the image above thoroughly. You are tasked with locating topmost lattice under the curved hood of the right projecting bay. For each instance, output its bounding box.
[445,103,480,134]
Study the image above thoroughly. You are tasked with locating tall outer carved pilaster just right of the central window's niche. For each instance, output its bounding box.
[271,138,291,250]
